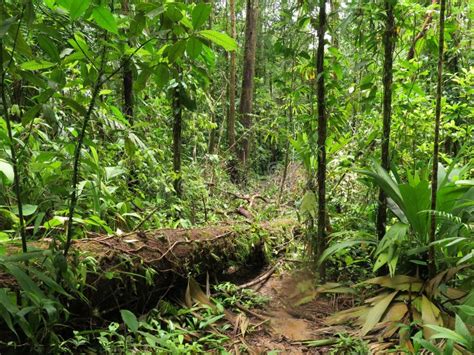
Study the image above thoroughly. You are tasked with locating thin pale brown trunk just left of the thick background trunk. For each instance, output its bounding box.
[227,0,237,152]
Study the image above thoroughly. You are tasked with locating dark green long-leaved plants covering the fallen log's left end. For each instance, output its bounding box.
[0,251,93,351]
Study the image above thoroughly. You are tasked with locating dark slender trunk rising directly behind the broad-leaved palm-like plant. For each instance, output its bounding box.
[377,0,395,248]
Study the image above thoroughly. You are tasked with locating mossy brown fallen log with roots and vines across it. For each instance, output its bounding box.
[0,219,296,319]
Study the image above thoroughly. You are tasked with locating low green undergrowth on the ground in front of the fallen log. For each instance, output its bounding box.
[58,282,268,354]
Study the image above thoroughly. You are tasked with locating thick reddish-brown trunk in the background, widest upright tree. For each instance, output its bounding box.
[239,0,258,177]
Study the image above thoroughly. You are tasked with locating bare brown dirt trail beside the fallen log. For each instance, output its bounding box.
[234,270,350,354]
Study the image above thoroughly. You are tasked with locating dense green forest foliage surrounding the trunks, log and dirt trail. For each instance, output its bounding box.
[0,0,474,353]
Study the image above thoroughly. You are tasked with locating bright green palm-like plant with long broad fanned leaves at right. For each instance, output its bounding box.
[363,164,474,275]
